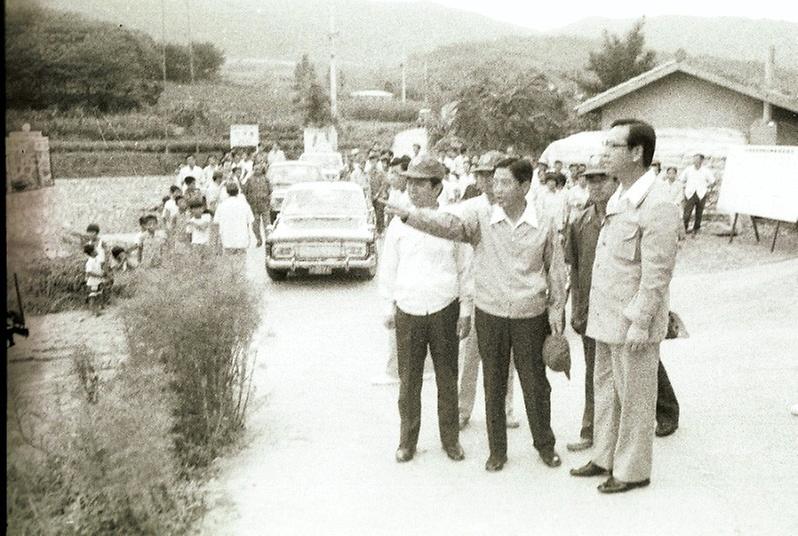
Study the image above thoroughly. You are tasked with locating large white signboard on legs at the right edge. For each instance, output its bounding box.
[718,145,798,223]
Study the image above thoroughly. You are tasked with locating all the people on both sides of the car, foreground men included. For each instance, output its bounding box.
[73,125,714,493]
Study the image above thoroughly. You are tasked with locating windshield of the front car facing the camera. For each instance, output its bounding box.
[282,188,366,219]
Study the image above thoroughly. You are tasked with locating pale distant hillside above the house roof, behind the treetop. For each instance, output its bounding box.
[552,16,798,70]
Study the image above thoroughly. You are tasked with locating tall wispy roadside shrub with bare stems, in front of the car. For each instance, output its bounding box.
[122,256,260,470]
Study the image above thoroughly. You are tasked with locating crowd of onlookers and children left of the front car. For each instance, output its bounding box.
[76,143,285,315]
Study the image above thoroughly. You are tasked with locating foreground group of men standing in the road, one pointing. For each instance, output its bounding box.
[380,120,682,493]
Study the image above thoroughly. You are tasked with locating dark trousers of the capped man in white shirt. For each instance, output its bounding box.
[395,300,460,449]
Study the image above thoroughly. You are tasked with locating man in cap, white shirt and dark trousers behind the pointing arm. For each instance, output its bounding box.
[380,158,473,462]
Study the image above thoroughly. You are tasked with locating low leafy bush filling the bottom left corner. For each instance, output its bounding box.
[6,347,204,535]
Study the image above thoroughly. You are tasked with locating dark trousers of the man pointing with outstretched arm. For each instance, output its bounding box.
[474,308,555,458]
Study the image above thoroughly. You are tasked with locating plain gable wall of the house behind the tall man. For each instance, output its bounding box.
[601,72,762,133]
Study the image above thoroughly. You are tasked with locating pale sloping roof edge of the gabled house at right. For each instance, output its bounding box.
[576,60,798,115]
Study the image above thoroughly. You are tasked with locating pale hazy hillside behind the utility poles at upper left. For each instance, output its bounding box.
[42,0,533,65]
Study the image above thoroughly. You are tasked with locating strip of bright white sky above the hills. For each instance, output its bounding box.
[378,0,798,30]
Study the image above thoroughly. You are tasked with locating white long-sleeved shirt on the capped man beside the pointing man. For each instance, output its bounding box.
[379,209,474,318]
